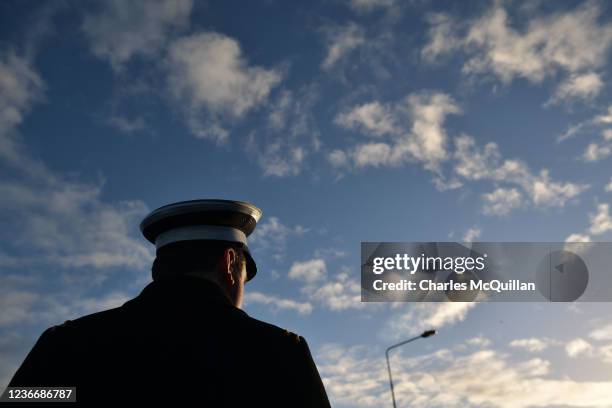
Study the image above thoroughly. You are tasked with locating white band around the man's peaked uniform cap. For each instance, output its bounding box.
[155,225,247,249]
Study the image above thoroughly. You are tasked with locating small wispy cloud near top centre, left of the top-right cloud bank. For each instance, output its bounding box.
[321,23,366,70]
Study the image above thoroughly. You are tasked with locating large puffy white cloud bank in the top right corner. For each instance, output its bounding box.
[422,2,612,102]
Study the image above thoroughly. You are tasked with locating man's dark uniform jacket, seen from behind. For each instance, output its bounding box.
[9,276,329,407]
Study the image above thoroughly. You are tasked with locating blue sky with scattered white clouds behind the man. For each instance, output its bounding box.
[0,0,612,408]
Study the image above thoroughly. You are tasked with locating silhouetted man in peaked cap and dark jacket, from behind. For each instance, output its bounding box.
[9,200,329,407]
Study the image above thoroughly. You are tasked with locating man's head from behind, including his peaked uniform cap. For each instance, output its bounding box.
[140,200,262,307]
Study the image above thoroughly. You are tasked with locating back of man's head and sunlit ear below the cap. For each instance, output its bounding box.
[152,240,248,307]
